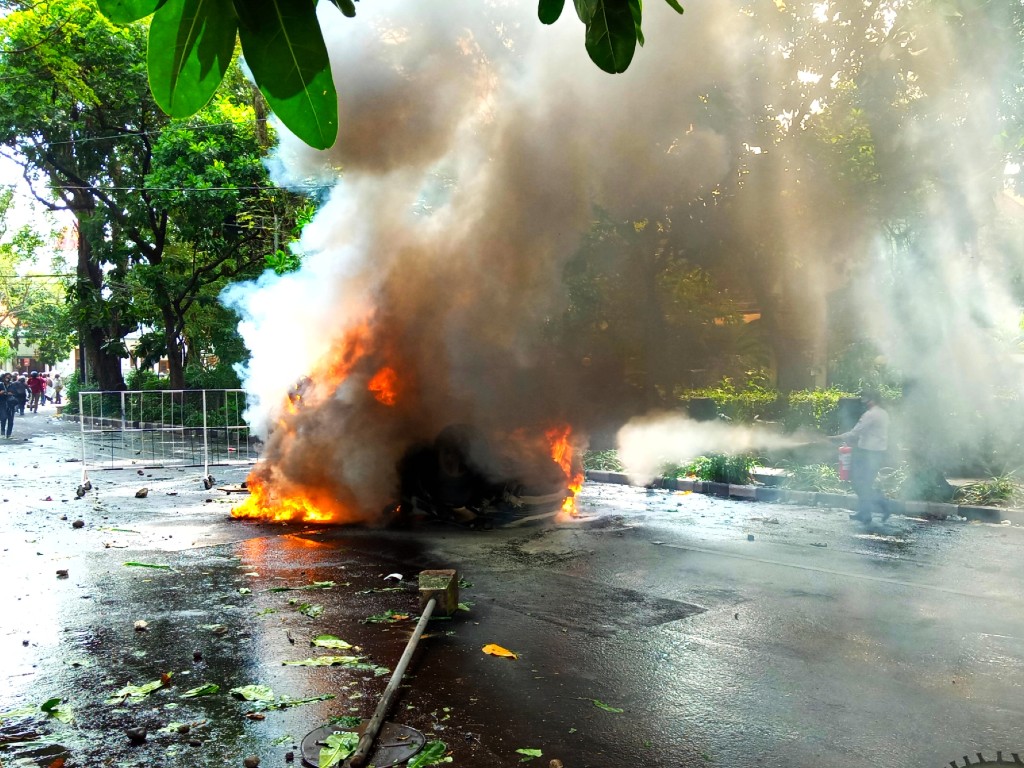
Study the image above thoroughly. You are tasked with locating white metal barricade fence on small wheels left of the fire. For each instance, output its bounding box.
[74,389,260,487]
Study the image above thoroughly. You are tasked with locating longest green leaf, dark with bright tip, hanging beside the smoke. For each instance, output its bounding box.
[234,0,338,150]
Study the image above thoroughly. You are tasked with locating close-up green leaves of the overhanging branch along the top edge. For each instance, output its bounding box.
[97,0,683,150]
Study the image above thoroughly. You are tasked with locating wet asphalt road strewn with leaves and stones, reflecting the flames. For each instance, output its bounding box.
[0,414,1024,768]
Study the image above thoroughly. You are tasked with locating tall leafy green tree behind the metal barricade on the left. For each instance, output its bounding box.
[0,0,305,389]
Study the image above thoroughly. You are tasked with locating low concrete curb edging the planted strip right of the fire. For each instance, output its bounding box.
[586,470,1024,524]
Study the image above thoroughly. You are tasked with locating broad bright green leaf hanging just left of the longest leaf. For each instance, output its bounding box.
[147,0,238,118]
